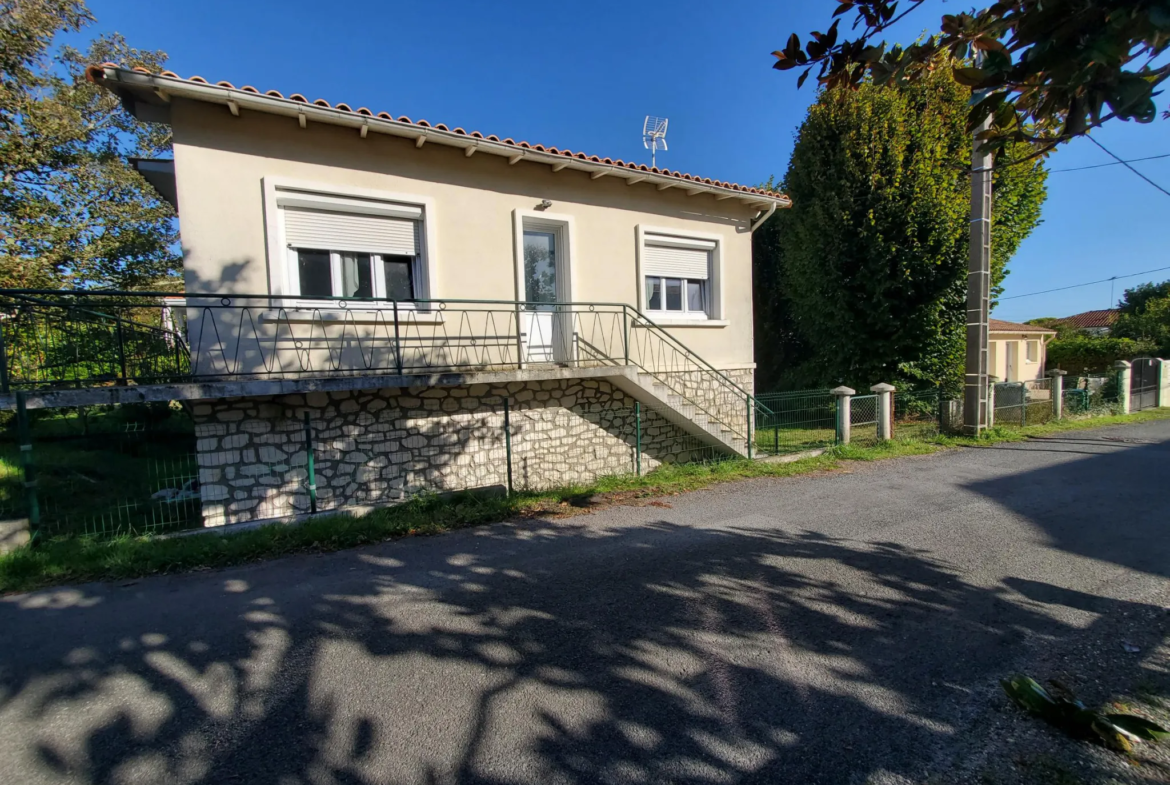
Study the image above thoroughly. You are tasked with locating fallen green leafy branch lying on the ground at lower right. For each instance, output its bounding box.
[1000,674,1170,752]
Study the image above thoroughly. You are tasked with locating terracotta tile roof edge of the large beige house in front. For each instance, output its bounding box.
[85,63,787,200]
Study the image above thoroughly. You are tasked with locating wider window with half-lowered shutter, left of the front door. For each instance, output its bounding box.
[277,193,427,302]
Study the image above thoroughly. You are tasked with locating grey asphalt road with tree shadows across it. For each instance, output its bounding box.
[0,421,1170,785]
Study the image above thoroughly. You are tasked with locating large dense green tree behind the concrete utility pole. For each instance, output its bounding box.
[756,69,1046,390]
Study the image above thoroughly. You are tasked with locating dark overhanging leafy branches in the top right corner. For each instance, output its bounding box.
[773,0,1170,152]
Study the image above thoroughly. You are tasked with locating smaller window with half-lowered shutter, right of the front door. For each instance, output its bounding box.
[642,233,716,319]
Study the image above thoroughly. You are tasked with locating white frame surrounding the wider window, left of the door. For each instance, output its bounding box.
[262,177,438,314]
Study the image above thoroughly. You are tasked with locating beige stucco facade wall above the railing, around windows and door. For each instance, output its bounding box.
[171,99,756,367]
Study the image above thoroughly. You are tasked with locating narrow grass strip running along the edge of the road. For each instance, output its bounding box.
[0,409,1170,592]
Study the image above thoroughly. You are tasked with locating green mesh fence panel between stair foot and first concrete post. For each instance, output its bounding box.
[756,390,837,455]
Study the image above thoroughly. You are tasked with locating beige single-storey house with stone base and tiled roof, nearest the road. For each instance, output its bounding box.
[80,63,790,523]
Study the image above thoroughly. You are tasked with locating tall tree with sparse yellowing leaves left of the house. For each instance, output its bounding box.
[0,0,181,289]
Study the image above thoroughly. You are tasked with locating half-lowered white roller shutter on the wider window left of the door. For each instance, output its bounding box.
[281,207,419,256]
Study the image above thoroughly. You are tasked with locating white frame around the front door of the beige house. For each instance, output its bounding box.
[512,208,577,367]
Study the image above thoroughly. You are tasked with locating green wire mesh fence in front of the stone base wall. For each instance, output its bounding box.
[0,393,731,540]
